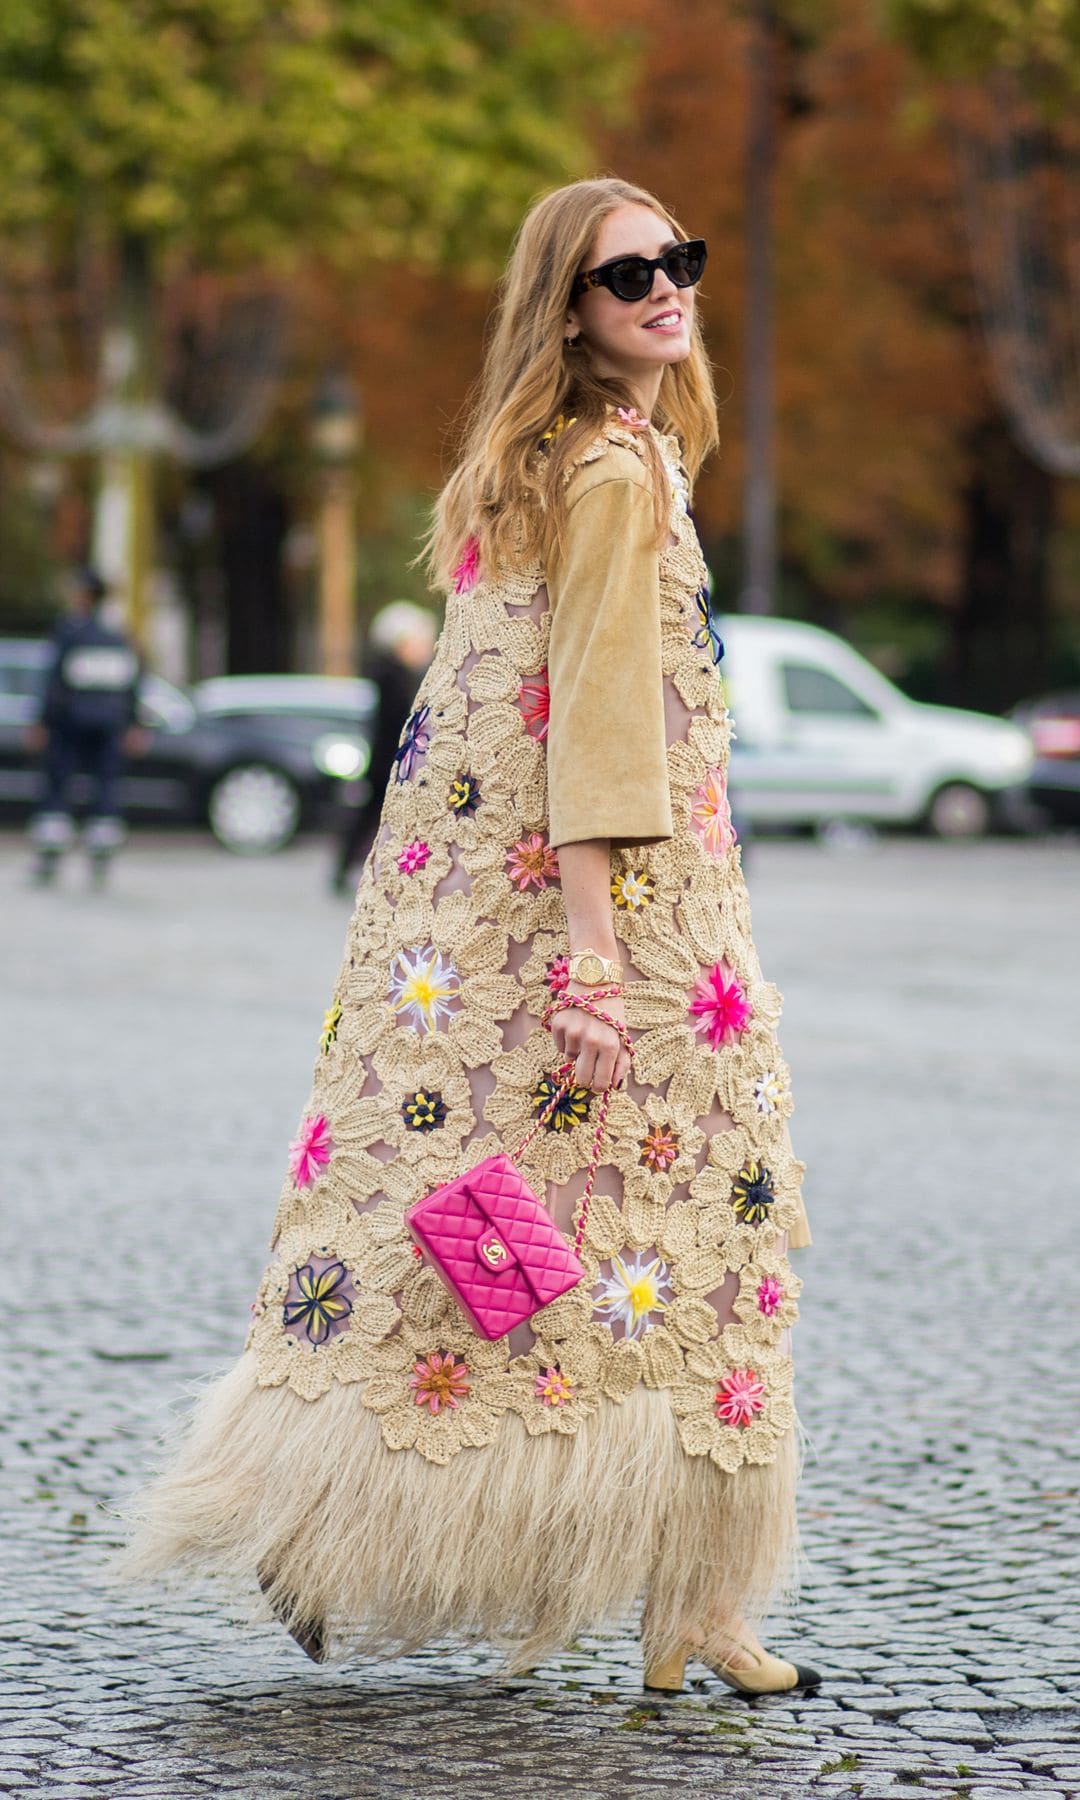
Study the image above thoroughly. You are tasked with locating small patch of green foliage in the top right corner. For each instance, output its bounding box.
[884,0,1080,110]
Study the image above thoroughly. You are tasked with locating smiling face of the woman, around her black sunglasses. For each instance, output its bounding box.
[567,202,695,409]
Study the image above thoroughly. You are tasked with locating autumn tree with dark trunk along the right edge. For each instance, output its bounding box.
[887,0,1080,704]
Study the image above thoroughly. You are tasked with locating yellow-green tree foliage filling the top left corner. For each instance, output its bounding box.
[0,0,628,275]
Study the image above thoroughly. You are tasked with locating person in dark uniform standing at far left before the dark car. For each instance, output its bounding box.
[29,569,142,884]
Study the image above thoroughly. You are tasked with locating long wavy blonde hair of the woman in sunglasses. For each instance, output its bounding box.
[423,175,718,589]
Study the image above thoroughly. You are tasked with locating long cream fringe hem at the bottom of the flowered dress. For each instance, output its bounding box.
[115,1355,799,1672]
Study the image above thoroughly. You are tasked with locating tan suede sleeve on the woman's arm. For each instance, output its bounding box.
[547,452,671,850]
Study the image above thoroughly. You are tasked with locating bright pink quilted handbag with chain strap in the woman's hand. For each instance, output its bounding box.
[405,1006,630,1337]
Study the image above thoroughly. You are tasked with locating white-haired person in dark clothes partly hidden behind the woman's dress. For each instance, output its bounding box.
[331,599,436,895]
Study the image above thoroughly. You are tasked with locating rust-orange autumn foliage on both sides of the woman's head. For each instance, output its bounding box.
[310,0,988,601]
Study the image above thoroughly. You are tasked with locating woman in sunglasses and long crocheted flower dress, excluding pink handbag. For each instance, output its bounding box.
[122,178,817,1692]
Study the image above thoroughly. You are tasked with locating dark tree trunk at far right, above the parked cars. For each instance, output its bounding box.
[945,414,1055,713]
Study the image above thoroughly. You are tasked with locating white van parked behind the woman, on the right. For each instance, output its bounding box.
[718,614,1033,837]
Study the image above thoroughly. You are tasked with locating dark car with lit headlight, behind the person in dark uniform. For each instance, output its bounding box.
[0,637,376,855]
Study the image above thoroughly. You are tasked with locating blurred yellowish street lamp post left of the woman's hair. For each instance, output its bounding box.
[311,369,362,675]
